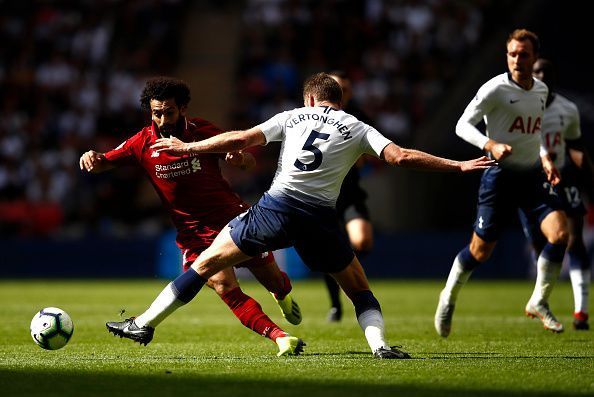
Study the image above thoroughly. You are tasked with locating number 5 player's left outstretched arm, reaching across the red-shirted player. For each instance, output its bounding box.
[151,127,266,154]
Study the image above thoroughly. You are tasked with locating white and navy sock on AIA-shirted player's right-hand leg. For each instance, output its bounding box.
[530,243,566,304]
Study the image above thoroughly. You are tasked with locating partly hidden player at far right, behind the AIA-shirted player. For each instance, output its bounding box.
[522,58,594,330]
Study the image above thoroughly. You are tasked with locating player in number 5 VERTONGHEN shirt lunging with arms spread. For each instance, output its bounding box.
[114,73,494,359]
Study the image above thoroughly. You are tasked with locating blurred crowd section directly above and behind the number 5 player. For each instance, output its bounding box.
[232,0,494,194]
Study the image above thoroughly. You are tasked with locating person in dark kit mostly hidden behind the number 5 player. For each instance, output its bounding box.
[324,70,373,322]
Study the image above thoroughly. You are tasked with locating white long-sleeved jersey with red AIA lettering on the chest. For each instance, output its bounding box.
[456,73,549,169]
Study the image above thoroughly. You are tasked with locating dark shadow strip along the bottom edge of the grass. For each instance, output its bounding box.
[0,363,578,397]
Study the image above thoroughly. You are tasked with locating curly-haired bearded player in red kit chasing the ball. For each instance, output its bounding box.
[80,77,302,355]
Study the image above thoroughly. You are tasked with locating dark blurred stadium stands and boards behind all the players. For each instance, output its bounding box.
[0,0,594,278]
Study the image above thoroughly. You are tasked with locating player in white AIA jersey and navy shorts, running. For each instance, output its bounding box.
[434,29,569,337]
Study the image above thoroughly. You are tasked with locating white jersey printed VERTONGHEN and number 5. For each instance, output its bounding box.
[258,106,391,207]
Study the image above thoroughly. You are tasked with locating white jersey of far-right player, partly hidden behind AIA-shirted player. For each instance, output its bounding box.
[542,93,582,169]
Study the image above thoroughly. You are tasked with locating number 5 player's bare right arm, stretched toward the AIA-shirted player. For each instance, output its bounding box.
[381,143,496,172]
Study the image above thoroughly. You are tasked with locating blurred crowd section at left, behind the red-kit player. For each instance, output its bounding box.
[0,0,184,236]
